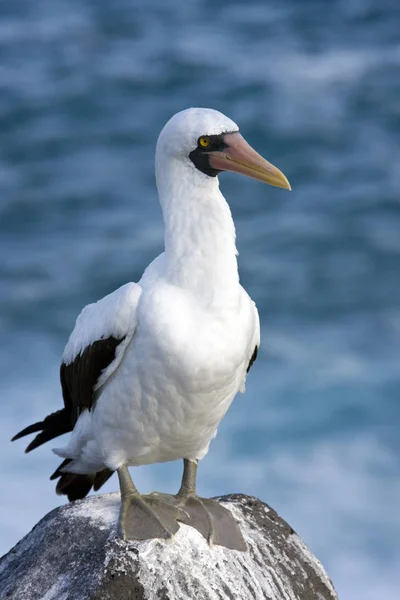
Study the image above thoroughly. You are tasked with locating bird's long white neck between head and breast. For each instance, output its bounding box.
[156,161,239,306]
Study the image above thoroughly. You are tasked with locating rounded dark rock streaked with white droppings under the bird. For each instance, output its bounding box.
[0,494,337,600]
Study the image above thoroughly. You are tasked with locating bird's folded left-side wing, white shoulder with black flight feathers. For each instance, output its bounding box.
[60,283,141,424]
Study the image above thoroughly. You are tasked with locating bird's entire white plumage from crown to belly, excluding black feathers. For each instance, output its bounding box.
[55,109,260,473]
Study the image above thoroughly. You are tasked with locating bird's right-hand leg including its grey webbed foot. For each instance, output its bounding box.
[175,459,247,551]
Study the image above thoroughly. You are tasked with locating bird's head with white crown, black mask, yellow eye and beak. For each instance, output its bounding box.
[157,108,291,190]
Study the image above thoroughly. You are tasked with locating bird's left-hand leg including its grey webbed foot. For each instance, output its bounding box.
[118,465,188,540]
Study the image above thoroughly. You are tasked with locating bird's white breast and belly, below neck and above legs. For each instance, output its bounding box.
[96,281,256,466]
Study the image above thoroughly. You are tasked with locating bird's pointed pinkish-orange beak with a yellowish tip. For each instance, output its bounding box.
[208,132,292,190]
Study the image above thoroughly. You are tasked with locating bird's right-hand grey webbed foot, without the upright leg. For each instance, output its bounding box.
[153,494,247,552]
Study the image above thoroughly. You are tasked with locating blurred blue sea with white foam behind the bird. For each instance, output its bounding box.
[0,0,400,600]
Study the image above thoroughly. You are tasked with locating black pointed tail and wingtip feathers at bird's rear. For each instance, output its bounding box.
[11,408,113,501]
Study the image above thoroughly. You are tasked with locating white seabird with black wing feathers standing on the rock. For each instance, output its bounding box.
[13,108,291,550]
